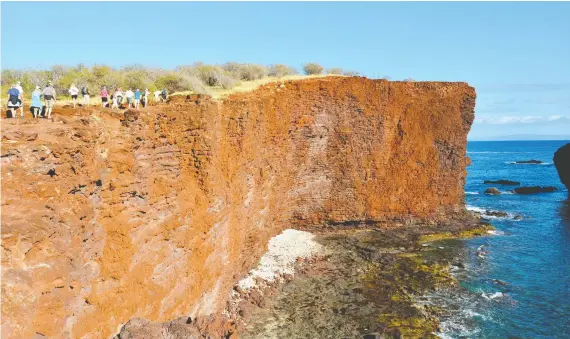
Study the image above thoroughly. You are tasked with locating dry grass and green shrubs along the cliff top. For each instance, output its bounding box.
[2,62,358,99]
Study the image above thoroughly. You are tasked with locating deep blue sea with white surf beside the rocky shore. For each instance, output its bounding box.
[420,141,570,338]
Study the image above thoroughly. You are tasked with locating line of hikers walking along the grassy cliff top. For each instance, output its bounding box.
[8,81,168,119]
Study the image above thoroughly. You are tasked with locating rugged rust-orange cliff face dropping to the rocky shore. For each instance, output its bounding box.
[2,78,475,338]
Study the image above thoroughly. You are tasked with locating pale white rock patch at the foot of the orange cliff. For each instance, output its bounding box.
[238,229,323,290]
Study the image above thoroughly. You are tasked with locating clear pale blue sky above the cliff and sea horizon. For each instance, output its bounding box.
[1,2,570,139]
